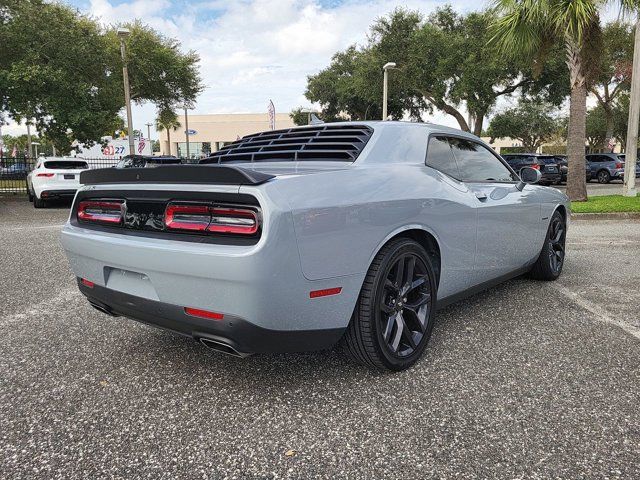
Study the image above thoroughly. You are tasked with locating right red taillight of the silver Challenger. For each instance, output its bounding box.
[164,203,259,235]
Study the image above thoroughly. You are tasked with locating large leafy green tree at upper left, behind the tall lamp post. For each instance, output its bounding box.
[0,0,201,151]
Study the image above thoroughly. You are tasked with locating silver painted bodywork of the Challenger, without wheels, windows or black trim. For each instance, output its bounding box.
[62,122,569,342]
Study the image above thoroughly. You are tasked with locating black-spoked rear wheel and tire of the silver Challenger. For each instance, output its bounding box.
[343,238,437,371]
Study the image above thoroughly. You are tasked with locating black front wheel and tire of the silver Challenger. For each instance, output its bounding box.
[529,211,567,281]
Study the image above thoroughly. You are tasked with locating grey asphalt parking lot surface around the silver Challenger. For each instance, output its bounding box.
[0,198,640,479]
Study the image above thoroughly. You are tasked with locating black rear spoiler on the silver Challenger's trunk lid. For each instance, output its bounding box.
[80,165,275,185]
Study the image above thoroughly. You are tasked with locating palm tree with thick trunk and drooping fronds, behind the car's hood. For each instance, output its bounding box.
[492,0,638,201]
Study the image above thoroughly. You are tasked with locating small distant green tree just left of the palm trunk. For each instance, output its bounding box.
[487,99,558,152]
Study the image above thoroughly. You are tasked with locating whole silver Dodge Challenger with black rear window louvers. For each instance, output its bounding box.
[62,121,570,370]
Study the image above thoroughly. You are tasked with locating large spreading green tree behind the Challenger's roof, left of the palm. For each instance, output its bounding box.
[306,7,567,134]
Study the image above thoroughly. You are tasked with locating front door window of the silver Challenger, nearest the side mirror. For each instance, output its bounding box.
[449,138,515,182]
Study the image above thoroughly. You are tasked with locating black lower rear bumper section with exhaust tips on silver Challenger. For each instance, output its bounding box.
[78,279,344,356]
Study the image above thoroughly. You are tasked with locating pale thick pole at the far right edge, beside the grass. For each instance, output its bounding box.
[622,15,640,197]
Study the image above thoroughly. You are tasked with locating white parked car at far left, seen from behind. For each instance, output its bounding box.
[26,157,89,208]
